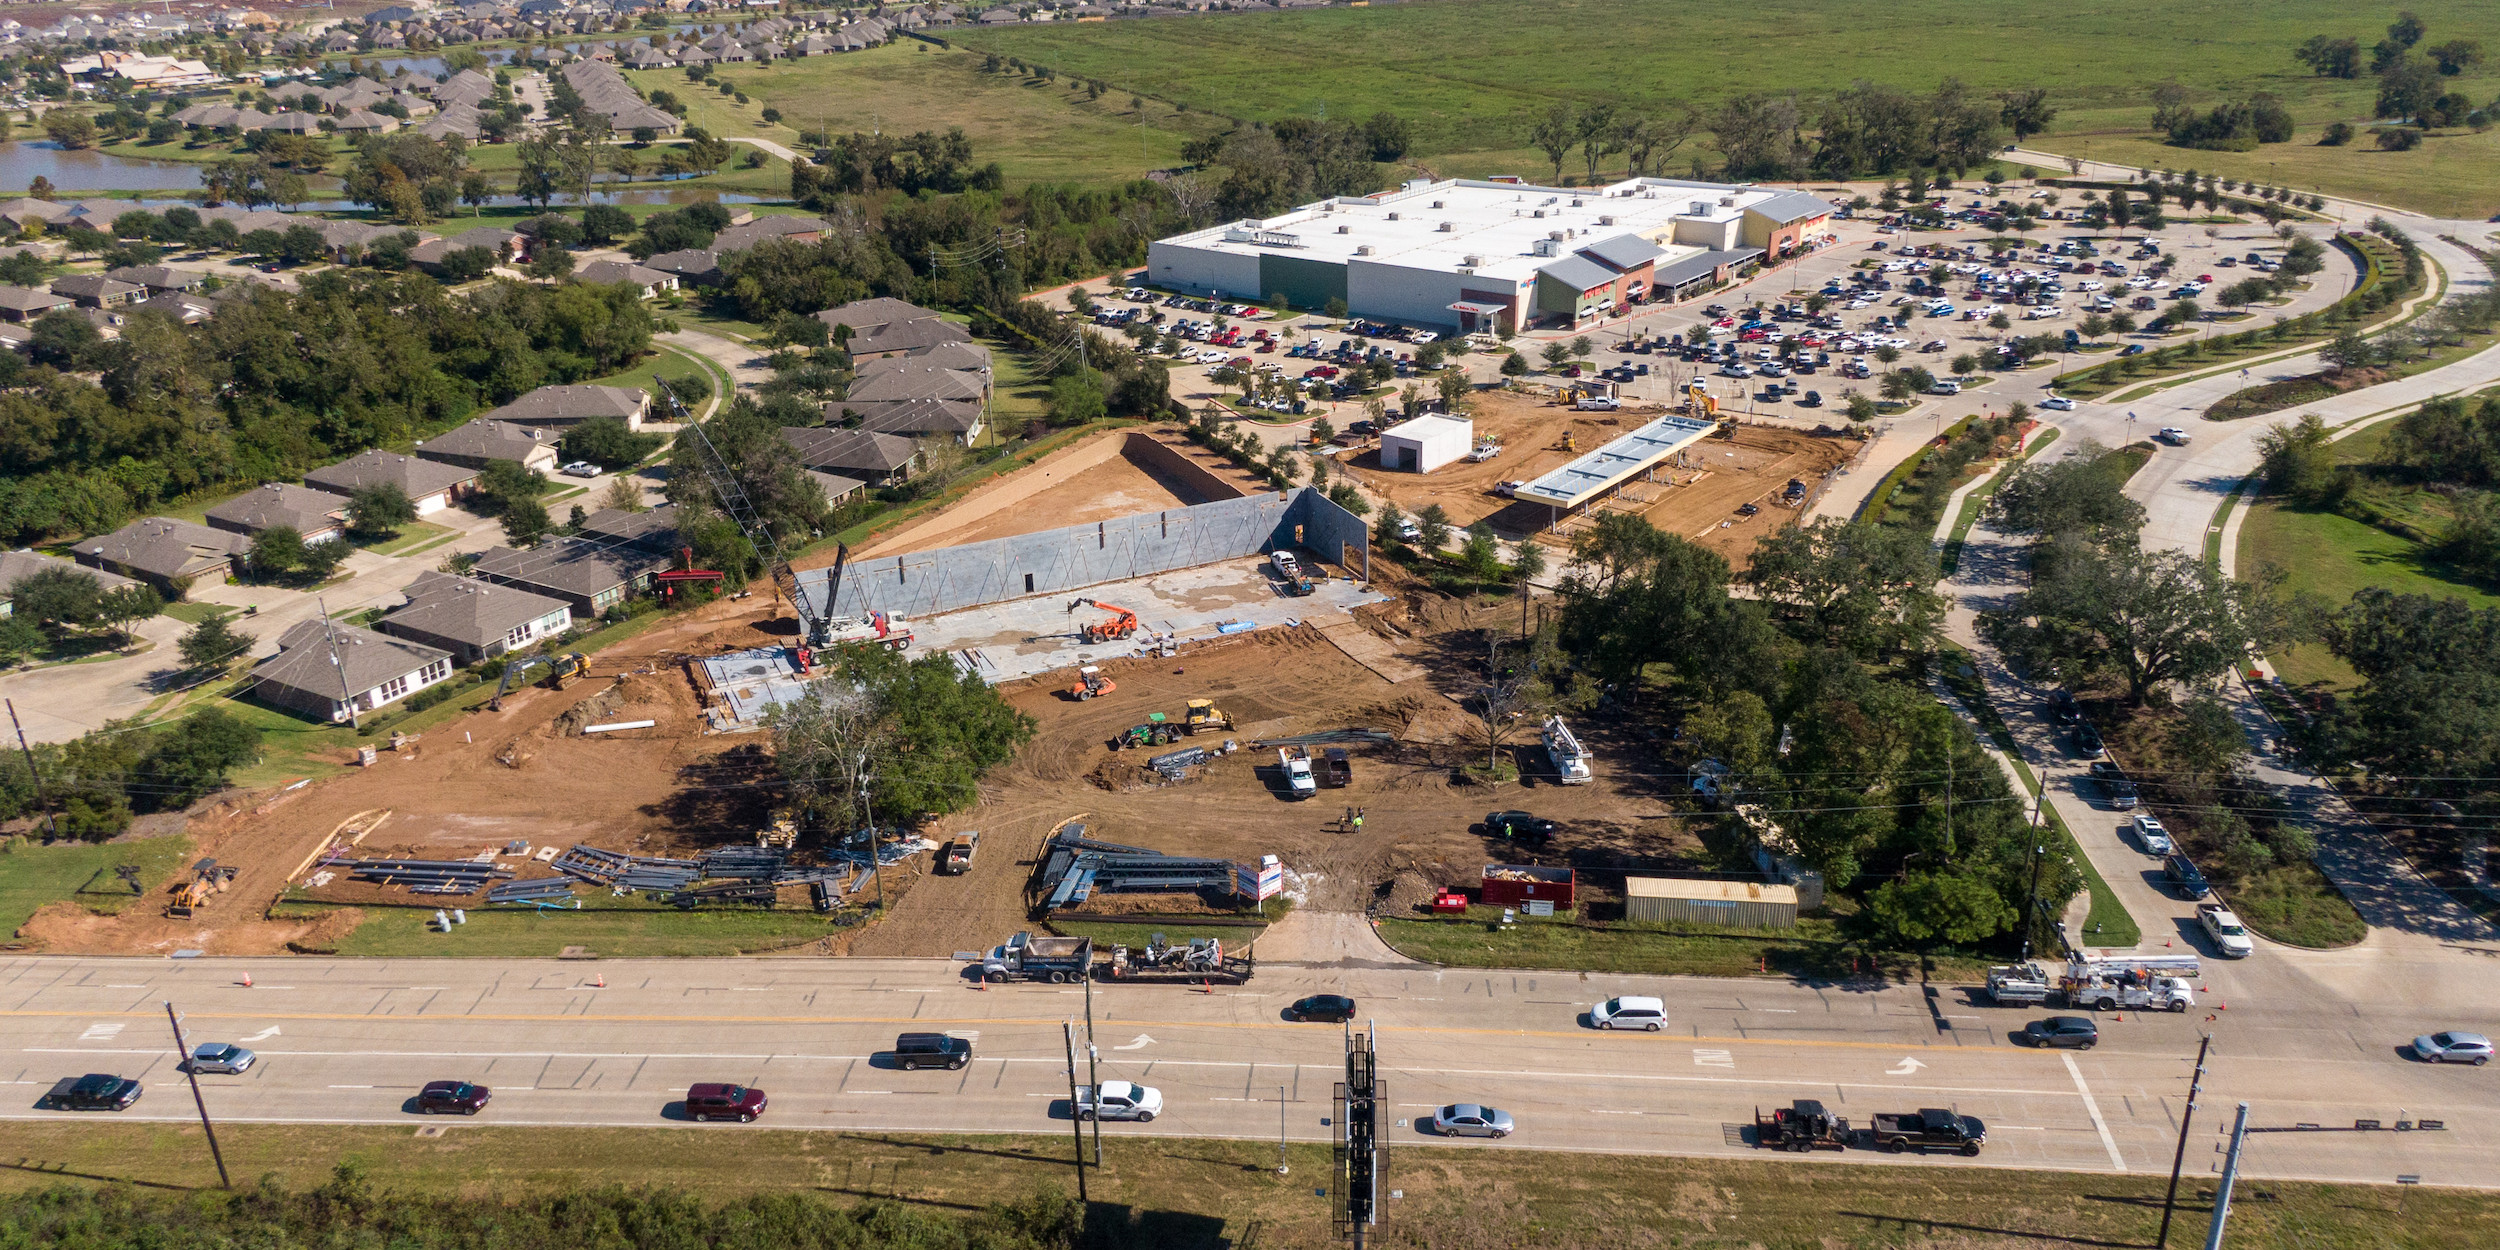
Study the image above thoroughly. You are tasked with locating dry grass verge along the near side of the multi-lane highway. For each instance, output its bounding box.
[0,1123,2500,1250]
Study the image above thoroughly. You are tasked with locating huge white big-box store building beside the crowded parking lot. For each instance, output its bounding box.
[1148,178,1835,333]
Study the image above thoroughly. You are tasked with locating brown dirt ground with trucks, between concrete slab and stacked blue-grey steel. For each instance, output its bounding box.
[853,598,1695,955]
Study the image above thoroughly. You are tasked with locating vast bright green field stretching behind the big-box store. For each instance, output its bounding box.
[950,0,2500,218]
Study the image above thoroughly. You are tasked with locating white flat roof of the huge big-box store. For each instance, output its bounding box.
[1163,178,1830,283]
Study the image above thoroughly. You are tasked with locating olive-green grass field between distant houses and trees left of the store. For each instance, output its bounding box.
[675,41,1223,183]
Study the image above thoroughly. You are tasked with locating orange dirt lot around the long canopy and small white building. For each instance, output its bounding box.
[1340,390,1858,568]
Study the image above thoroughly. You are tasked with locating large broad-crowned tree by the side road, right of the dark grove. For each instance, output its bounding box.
[1983,543,2280,703]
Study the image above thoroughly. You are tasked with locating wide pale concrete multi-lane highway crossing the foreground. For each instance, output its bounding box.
[0,950,2500,1185]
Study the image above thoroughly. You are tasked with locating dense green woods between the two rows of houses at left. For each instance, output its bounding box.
[0,270,653,545]
